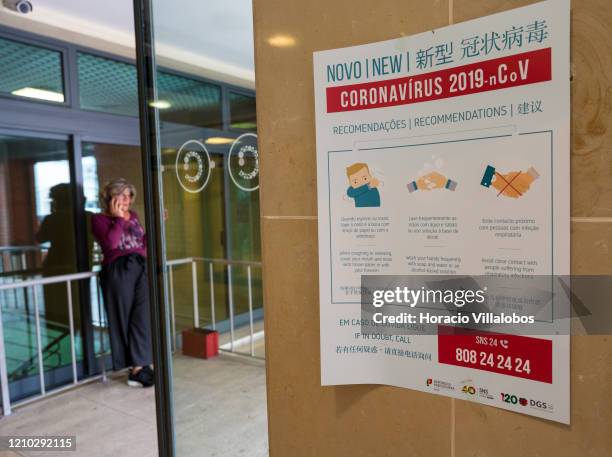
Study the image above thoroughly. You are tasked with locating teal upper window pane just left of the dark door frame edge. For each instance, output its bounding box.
[77,52,138,117]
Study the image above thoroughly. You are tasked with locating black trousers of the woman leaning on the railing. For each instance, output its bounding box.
[100,254,153,370]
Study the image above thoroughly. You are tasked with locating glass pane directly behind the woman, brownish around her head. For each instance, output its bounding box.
[82,143,146,355]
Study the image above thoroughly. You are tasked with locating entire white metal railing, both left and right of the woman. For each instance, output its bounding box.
[0,253,263,416]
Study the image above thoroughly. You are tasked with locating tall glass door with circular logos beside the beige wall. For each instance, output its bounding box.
[136,0,267,456]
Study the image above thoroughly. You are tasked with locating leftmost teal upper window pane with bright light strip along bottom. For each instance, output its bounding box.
[0,38,64,103]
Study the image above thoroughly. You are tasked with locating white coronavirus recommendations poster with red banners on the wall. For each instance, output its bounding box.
[314,0,570,423]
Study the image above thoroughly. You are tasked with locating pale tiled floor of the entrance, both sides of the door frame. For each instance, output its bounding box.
[0,354,268,457]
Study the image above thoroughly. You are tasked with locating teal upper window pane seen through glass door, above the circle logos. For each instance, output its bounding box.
[156,71,223,129]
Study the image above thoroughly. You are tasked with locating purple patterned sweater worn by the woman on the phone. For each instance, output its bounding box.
[91,211,147,265]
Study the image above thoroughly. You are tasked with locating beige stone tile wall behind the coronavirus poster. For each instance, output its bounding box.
[254,0,612,457]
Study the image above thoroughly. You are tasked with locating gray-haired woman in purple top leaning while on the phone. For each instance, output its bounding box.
[91,179,153,387]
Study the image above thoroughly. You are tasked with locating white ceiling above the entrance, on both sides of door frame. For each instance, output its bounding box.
[16,0,254,81]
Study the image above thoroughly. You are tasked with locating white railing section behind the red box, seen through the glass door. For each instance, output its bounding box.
[166,257,263,357]
